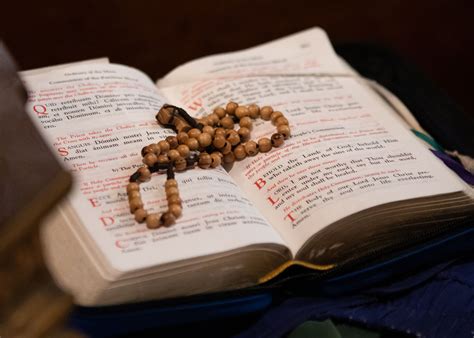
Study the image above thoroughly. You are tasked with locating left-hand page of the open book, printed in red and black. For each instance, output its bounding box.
[23,64,283,273]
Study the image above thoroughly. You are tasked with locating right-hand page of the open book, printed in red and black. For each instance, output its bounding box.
[158,29,464,254]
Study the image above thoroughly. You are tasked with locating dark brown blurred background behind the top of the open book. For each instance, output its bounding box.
[0,0,474,115]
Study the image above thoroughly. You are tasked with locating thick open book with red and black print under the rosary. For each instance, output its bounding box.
[22,28,474,305]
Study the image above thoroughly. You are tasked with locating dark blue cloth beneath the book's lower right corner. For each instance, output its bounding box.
[238,259,474,338]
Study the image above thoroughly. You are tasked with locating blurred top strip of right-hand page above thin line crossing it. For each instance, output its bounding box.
[159,28,346,87]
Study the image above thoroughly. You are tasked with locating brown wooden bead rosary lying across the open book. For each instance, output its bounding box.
[127,102,291,229]
